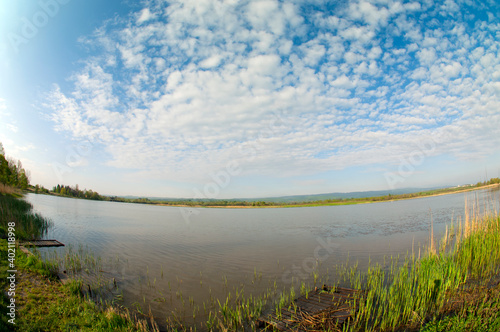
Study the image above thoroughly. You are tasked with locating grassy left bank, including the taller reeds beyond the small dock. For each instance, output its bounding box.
[0,191,156,332]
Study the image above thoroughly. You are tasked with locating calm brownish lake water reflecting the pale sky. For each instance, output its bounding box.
[26,189,499,325]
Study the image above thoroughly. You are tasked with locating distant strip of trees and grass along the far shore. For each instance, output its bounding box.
[27,178,500,208]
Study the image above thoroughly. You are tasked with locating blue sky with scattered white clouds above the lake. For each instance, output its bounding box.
[0,0,500,199]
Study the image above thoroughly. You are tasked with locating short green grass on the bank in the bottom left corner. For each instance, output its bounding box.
[0,239,156,331]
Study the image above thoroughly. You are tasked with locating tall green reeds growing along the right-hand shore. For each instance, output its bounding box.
[340,196,500,331]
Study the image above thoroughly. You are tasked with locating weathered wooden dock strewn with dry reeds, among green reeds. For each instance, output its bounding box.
[257,286,359,331]
